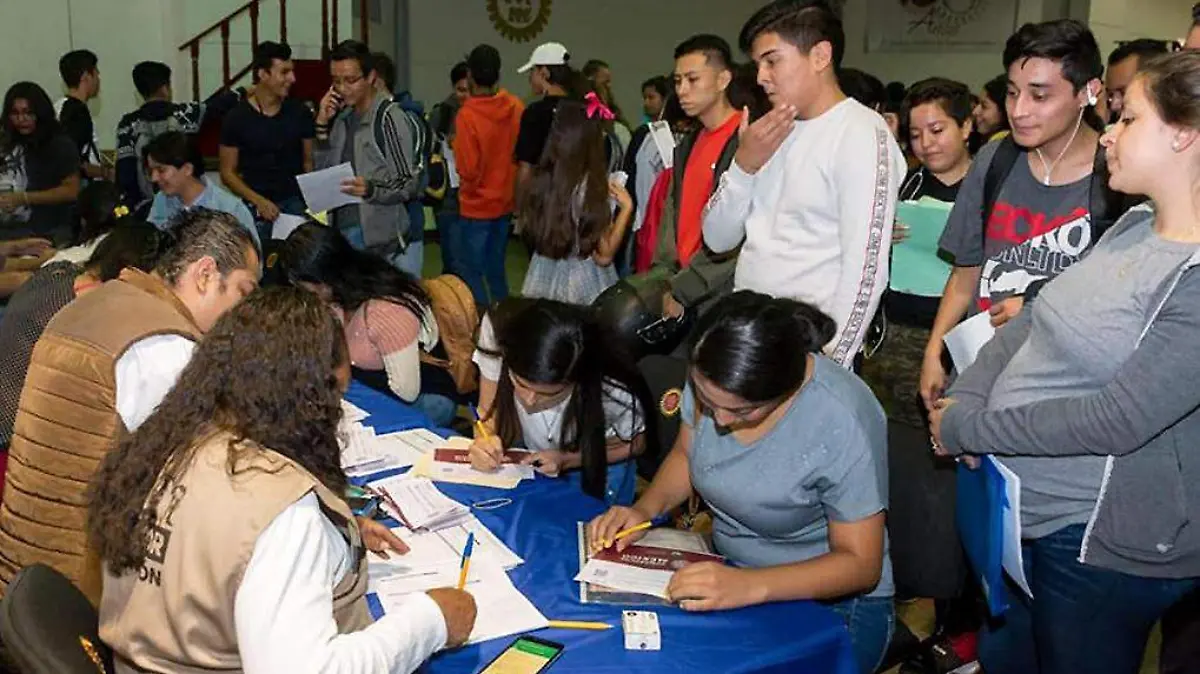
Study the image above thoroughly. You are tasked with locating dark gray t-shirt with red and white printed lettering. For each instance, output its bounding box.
[938,142,1093,313]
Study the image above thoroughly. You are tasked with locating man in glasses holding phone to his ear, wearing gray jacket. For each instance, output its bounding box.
[313,40,422,269]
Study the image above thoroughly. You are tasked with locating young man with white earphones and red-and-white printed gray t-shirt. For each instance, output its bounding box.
[920,19,1124,408]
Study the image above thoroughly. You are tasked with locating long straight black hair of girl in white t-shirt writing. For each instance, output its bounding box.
[488,299,653,499]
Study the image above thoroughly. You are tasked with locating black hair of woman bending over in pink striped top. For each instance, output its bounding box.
[278,222,430,321]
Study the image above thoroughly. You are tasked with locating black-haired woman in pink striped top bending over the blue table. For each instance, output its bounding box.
[280,222,456,426]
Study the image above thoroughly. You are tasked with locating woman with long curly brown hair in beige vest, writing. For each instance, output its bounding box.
[88,288,475,674]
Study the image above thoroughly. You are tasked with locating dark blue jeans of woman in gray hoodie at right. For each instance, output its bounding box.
[979,524,1198,674]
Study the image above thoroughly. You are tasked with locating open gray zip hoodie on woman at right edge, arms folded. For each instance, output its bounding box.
[941,204,1200,578]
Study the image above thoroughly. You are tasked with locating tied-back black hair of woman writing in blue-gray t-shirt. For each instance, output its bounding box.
[689,290,838,403]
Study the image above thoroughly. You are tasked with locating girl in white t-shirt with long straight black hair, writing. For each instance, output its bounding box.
[470,299,649,505]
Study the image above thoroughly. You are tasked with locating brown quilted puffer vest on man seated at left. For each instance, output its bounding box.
[0,269,200,603]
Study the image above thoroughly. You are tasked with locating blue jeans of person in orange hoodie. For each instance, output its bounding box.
[442,216,512,306]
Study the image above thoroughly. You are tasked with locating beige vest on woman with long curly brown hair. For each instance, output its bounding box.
[100,432,371,674]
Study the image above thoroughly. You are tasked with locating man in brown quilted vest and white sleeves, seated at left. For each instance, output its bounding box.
[0,209,260,603]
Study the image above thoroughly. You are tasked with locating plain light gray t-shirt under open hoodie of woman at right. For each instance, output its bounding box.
[988,212,1196,538]
